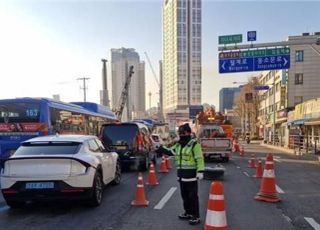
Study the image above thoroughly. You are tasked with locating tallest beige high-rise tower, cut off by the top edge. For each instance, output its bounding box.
[162,0,201,117]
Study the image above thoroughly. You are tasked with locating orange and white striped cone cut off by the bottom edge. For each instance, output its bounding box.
[204,181,227,230]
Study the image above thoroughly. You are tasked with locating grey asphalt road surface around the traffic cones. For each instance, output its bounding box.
[0,144,320,230]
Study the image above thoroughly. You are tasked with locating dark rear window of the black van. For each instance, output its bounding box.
[103,125,138,145]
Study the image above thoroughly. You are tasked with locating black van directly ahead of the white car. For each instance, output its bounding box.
[100,122,156,171]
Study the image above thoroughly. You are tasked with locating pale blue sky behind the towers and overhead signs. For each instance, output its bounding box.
[0,0,320,110]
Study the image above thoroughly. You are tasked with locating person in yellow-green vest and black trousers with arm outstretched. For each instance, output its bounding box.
[156,123,204,225]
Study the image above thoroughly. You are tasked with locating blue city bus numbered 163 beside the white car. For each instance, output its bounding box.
[0,98,117,165]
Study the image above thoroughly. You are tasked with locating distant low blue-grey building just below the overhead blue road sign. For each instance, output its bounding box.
[219,87,240,113]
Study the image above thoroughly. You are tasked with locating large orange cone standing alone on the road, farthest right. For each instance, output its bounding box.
[254,153,280,203]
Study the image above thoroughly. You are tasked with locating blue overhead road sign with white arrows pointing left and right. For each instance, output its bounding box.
[219,55,290,73]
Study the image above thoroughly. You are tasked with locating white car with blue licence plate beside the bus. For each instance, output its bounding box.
[1,135,121,208]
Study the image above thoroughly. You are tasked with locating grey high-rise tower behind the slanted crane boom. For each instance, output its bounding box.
[111,48,146,121]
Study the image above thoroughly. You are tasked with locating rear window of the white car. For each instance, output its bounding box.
[14,142,81,156]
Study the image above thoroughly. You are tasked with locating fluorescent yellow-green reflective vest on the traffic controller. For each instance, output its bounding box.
[171,139,204,179]
